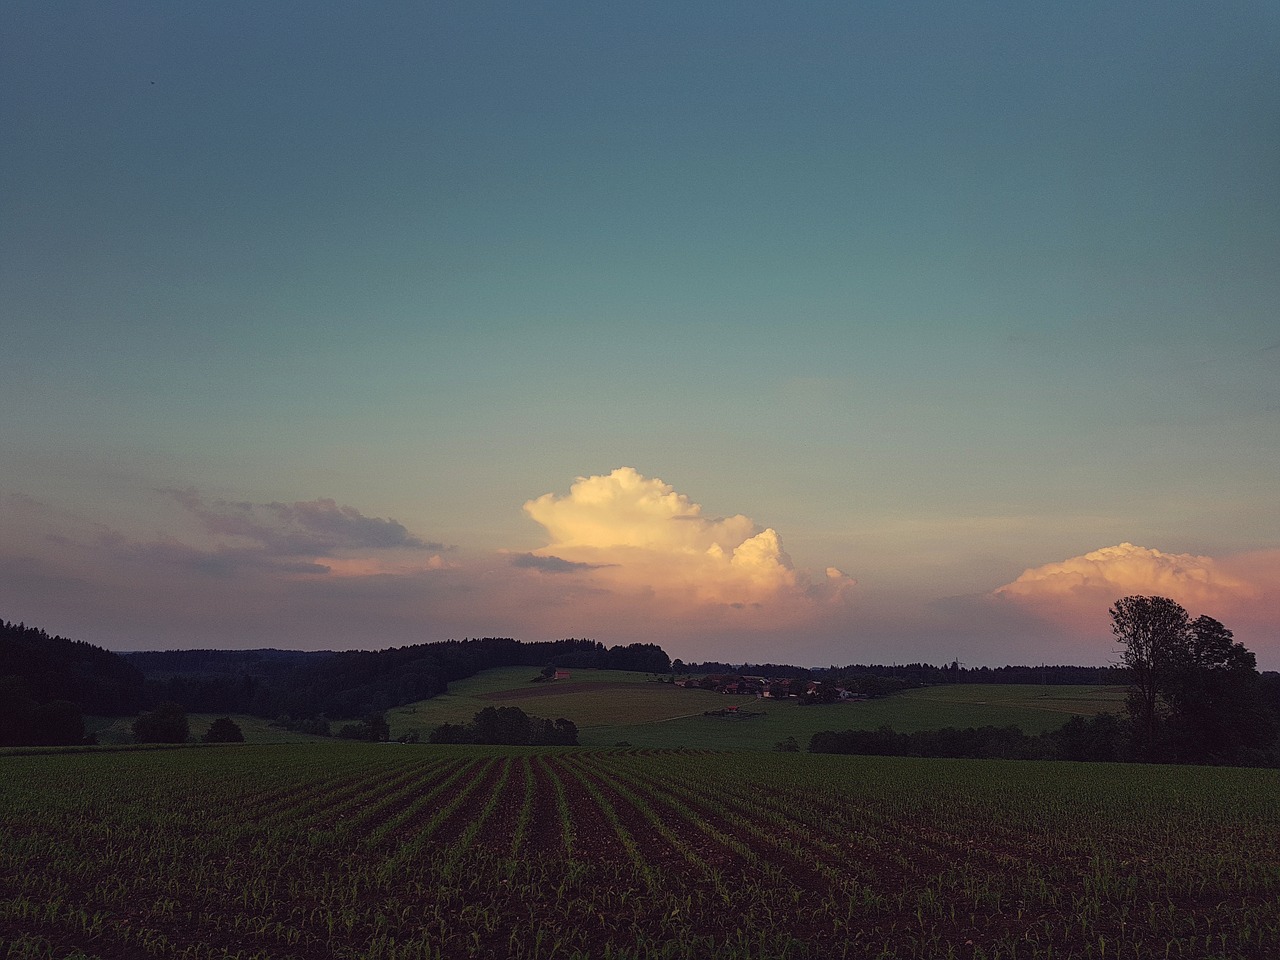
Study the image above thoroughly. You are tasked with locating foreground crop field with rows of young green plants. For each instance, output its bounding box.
[0,744,1280,960]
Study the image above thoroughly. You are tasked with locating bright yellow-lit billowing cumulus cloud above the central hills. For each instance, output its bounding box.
[514,467,852,619]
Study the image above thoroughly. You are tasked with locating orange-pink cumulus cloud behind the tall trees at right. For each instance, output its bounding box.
[989,543,1280,643]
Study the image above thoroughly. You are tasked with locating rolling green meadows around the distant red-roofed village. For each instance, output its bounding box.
[387,667,1124,750]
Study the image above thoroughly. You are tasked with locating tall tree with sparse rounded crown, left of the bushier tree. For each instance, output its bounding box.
[1111,596,1190,760]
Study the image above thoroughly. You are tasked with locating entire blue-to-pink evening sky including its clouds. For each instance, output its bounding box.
[0,0,1280,669]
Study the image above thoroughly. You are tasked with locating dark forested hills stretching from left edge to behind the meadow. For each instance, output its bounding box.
[0,622,671,746]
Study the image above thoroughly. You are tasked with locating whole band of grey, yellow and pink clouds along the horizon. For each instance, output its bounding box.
[0,488,1280,668]
